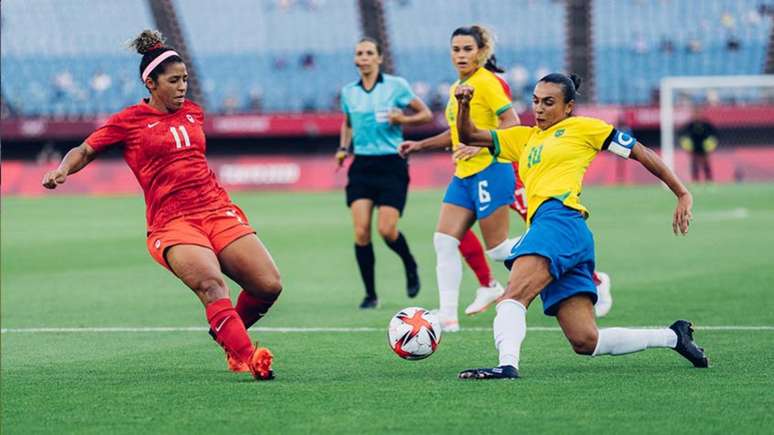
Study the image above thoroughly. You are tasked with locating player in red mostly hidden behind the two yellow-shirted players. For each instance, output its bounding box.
[457,74,613,317]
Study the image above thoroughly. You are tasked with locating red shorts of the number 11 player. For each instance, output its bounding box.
[147,204,255,271]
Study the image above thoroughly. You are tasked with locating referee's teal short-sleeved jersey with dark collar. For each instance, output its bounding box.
[341,73,416,156]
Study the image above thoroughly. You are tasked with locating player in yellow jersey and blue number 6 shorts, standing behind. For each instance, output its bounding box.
[400,26,519,331]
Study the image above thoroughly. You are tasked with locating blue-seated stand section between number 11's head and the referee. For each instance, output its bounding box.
[177,0,360,113]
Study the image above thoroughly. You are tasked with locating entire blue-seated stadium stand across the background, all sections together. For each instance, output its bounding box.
[1,0,774,119]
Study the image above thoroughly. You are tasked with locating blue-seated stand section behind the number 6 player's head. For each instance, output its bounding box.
[385,0,565,110]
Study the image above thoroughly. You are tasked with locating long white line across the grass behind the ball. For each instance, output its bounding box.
[0,325,774,334]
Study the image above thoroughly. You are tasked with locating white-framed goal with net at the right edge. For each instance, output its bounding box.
[660,75,774,182]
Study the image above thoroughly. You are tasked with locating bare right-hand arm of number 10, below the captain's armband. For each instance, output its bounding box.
[631,142,693,235]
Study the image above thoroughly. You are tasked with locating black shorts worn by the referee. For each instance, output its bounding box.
[347,154,409,214]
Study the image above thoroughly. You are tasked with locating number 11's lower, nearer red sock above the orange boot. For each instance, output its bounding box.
[205,298,254,361]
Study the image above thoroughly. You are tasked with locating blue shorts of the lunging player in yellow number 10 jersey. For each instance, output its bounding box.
[505,199,597,316]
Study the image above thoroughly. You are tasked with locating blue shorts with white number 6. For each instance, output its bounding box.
[443,162,516,219]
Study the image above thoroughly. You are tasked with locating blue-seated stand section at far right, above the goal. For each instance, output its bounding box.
[593,0,772,105]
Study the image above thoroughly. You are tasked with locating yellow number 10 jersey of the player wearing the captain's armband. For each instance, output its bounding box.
[491,116,620,225]
